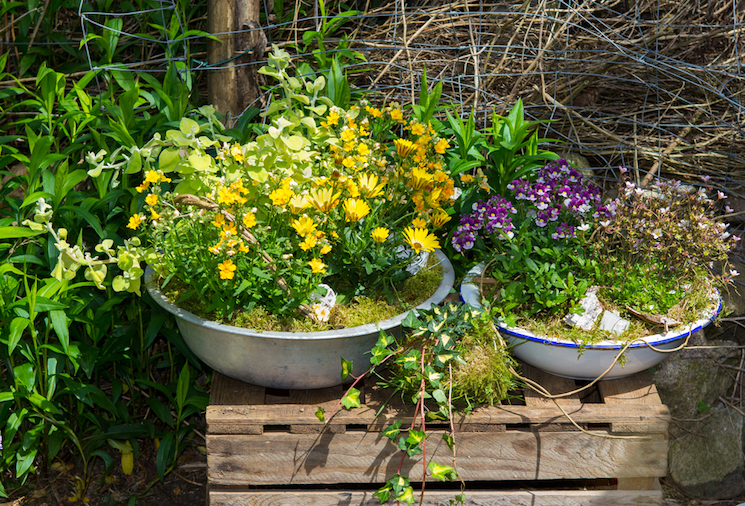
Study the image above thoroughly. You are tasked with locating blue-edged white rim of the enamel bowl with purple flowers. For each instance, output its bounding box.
[458,262,722,351]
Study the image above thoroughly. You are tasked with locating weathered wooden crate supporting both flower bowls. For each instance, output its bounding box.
[207,366,670,506]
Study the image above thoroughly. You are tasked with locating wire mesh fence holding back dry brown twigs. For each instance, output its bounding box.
[81,0,745,193]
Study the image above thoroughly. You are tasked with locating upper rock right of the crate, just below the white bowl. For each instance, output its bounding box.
[654,338,740,419]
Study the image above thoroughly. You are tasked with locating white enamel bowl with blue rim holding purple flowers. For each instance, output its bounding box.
[460,264,722,380]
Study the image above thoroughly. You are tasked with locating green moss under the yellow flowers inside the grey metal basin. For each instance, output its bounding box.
[154,255,442,332]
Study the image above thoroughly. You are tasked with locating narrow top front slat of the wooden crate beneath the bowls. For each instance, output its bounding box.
[206,404,670,434]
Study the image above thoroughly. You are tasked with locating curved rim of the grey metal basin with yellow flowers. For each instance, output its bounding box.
[145,249,455,340]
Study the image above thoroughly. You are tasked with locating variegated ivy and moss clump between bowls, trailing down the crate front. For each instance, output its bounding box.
[316,303,515,504]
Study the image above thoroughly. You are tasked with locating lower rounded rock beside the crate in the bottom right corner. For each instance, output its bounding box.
[669,407,745,500]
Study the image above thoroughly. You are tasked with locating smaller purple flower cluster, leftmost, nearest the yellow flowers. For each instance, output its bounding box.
[452,195,517,253]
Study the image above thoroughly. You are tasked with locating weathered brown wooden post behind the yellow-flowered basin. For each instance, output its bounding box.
[207,0,266,127]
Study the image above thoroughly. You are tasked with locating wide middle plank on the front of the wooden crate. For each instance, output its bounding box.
[207,431,667,486]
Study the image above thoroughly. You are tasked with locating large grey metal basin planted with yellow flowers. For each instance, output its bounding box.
[145,250,455,389]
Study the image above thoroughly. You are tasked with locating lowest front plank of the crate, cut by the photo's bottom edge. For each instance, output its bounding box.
[209,488,663,506]
